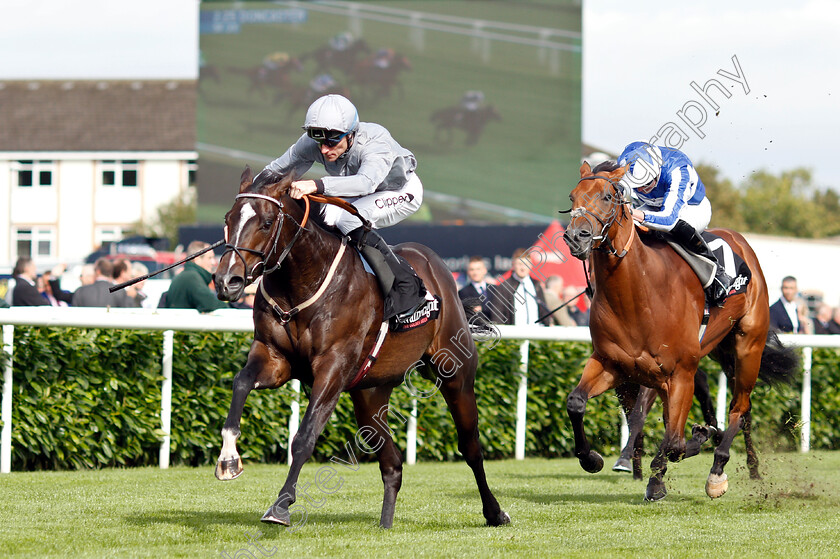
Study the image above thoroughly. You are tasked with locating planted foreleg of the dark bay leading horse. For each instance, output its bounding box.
[260,374,344,526]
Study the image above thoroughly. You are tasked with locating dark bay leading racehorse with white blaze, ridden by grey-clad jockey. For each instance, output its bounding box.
[215,168,510,528]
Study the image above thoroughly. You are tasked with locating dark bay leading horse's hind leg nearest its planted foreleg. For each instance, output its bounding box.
[350,387,405,528]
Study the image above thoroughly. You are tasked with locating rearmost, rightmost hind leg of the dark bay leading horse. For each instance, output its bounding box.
[437,356,510,526]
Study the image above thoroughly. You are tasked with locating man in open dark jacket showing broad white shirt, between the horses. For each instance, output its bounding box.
[486,248,551,326]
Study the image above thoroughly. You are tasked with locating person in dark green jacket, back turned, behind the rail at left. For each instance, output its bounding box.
[164,241,230,312]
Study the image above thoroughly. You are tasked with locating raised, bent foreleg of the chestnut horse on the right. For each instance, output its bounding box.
[566,354,616,474]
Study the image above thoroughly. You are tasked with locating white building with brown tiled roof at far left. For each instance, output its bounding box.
[0,80,197,266]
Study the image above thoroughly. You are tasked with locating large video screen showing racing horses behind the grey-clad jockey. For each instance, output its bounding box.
[198,0,581,223]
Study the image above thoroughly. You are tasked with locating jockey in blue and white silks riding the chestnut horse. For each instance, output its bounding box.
[618,142,732,305]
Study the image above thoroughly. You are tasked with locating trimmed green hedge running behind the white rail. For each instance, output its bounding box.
[0,327,840,470]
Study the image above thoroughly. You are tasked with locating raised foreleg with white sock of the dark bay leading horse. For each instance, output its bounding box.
[216,341,291,481]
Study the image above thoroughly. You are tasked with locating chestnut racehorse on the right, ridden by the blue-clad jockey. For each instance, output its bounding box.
[564,162,798,501]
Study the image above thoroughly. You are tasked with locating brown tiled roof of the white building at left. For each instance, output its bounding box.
[0,80,196,151]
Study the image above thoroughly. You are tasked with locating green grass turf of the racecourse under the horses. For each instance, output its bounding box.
[0,452,840,558]
